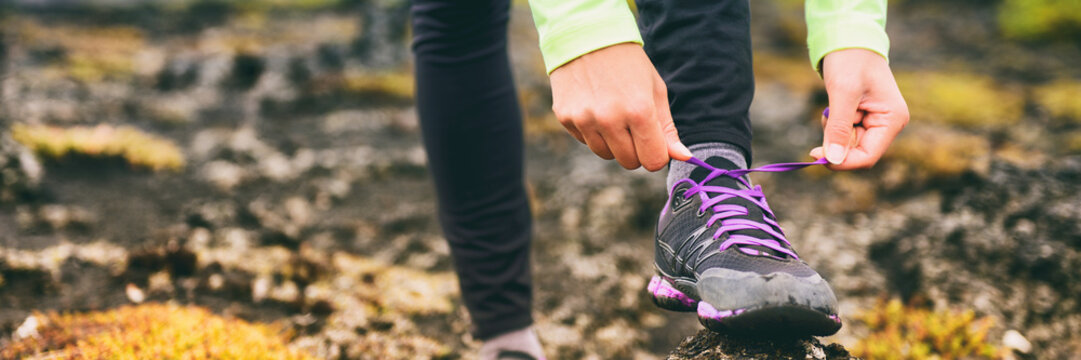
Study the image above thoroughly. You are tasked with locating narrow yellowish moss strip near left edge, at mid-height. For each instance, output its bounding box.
[12,124,184,171]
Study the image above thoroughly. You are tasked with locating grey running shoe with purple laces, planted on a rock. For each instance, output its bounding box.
[648,157,841,336]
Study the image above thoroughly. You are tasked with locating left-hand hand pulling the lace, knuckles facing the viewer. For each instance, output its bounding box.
[550,43,691,171]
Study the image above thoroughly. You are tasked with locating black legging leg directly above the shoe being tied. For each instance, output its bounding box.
[636,0,755,162]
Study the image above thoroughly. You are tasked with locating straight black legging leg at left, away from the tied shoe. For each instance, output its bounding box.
[411,0,533,338]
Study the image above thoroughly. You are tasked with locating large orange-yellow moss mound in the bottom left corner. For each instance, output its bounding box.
[0,304,312,359]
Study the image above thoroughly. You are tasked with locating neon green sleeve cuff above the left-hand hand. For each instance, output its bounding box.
[530,0,642,74]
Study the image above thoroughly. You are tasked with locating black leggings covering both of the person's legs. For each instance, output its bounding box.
[412,0,753,339]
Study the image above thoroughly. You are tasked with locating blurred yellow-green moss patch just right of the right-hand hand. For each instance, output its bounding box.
[897,72,1025,129]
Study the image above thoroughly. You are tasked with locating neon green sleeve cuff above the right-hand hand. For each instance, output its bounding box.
[804,0,890,74]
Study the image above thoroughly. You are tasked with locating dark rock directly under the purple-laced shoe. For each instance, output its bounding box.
[667,330,856,360]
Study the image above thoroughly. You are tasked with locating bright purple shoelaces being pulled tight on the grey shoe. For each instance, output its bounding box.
[683,158,827,259]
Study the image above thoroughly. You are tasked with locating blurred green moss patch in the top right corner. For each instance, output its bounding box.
[998,0,1081,40]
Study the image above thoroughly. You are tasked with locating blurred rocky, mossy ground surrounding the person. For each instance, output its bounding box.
[0,0,1081,359]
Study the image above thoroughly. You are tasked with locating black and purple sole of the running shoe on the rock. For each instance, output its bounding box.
[646,276,841,337]
